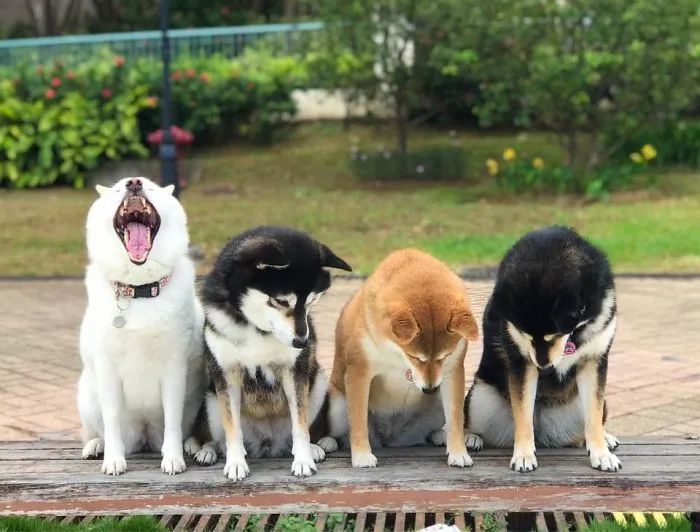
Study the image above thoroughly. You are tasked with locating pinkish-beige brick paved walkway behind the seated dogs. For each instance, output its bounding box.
[0,278,700,440]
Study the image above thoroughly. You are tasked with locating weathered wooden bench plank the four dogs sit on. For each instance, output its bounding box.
[0,437,700,530]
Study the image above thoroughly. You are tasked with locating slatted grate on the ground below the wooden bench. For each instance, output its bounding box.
[30,512,698,532]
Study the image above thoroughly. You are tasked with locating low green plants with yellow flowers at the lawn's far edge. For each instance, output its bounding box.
[485,144,657,198]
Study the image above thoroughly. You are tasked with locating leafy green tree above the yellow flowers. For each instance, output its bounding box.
[432,0,700,171]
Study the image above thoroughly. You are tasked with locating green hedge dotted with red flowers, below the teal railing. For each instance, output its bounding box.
[0,50,307,188]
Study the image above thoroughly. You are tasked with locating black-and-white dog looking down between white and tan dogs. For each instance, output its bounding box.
[195,227,351,480]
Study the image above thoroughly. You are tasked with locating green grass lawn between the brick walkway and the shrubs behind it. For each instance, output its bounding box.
[0,124,700,276]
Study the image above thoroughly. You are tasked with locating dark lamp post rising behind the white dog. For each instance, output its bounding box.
[160,0,180,198]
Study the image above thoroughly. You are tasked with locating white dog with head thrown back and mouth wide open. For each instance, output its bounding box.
[78,178,205,475]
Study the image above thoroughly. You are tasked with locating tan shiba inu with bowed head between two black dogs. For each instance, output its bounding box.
[330,249,478,467]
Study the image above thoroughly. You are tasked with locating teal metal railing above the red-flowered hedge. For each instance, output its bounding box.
[0,22,323,65]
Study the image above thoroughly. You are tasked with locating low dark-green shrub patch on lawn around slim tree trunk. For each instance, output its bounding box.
[350,146,467,181]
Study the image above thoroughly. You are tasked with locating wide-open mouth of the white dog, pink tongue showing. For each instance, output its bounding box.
[114,194,160,264]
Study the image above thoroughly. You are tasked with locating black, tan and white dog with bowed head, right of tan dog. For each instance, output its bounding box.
[464,227,622,472]
